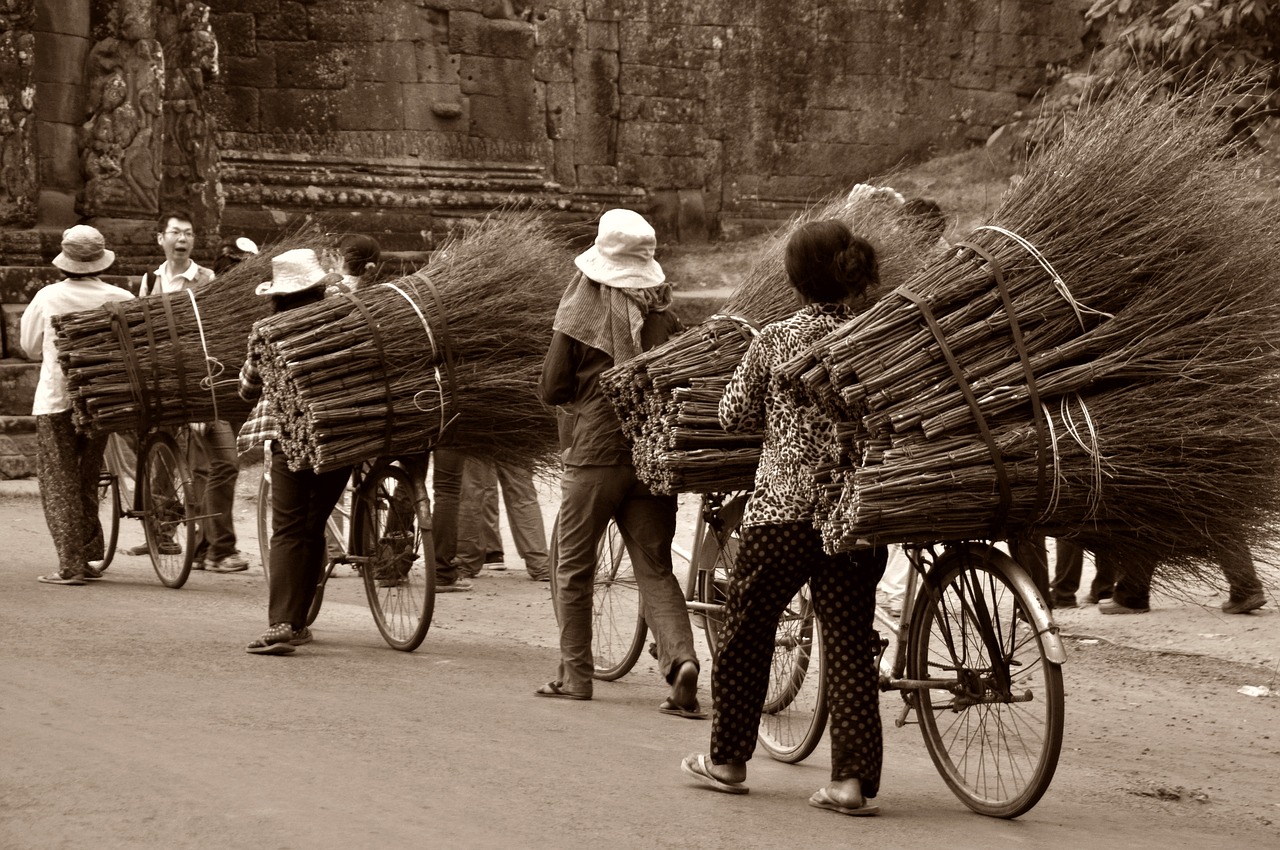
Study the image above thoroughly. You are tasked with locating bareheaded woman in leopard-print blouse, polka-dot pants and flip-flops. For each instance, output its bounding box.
[681,219,888,815]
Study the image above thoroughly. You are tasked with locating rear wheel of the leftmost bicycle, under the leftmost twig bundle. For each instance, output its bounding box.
[138,431,196,588]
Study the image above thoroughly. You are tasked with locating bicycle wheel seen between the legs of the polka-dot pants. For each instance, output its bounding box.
[759,585,827,764]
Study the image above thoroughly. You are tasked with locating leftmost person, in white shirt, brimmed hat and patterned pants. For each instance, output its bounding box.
[19,224,133,585]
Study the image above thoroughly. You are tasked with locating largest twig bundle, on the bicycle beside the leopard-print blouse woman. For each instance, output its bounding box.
[786,76,1280,578]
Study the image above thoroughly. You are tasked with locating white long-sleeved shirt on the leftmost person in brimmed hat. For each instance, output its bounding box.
[20,278,133,416]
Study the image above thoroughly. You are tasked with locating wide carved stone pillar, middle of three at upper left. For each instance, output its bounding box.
[77,0,164,220]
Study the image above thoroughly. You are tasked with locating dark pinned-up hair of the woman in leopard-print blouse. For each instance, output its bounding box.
[785,219,879,303]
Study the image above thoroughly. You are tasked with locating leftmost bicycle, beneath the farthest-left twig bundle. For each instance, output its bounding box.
[99,422,217,589]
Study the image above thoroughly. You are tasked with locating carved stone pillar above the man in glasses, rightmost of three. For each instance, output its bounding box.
[156,0,223,236]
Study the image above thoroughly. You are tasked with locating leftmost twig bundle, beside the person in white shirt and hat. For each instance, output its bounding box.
[54,230,328,431]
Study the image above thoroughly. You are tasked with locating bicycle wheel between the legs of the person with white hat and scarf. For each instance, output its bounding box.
[591,520,649,682]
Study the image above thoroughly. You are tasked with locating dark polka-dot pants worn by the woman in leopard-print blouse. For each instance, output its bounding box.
[710,522,888,798]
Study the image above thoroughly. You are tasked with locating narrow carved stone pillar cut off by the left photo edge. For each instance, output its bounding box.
[0,0,40,228]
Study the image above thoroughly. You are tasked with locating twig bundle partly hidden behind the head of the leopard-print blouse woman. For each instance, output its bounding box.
[600,185,936,493]
